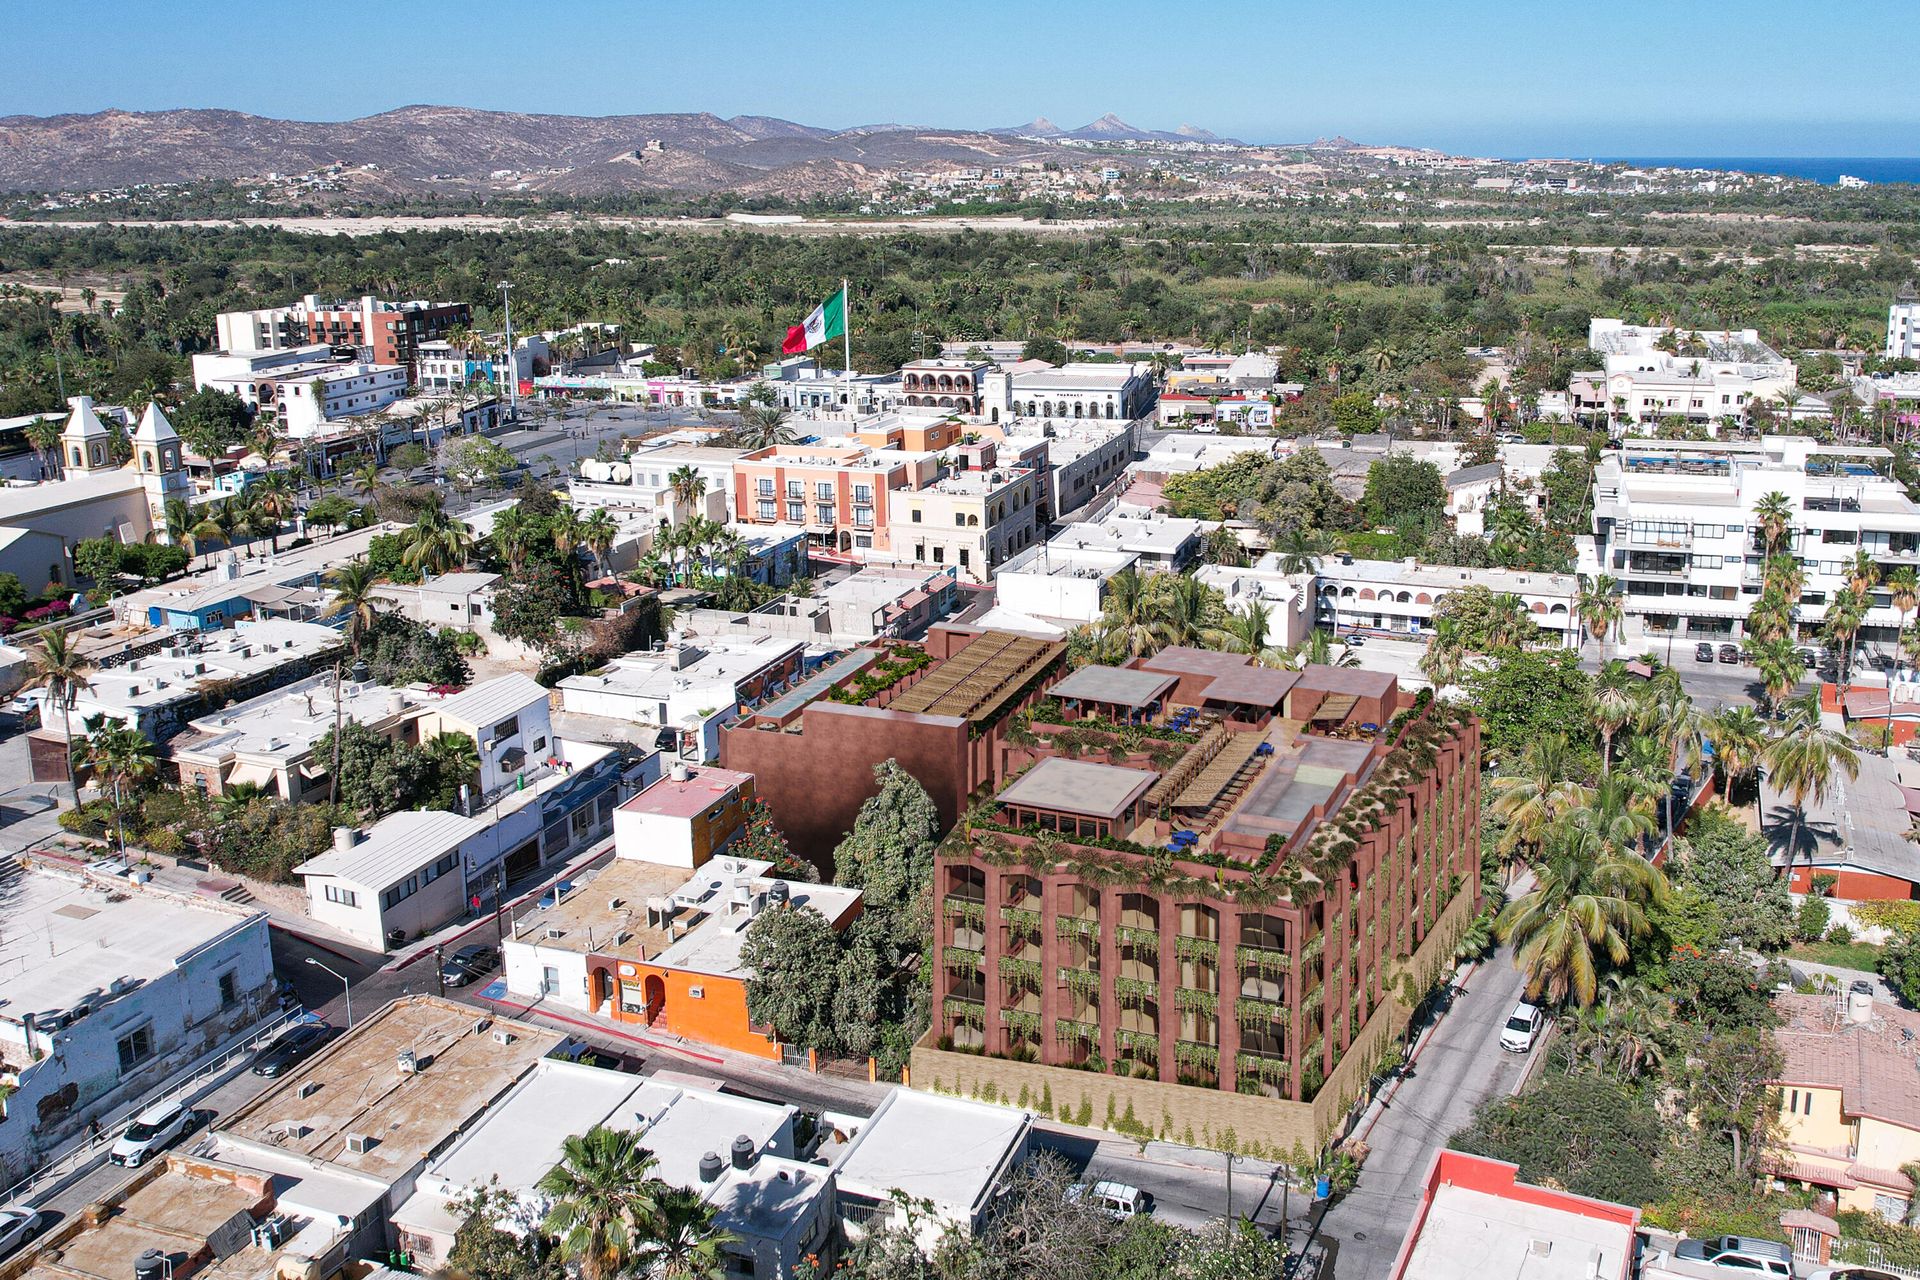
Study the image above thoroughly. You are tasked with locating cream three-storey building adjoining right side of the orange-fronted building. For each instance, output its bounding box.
[887,441,1043,581]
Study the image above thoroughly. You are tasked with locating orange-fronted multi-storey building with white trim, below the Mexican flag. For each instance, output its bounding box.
[733,445,937,553]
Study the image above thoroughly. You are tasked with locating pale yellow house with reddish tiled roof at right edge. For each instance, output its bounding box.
[1772,994,1920,1221]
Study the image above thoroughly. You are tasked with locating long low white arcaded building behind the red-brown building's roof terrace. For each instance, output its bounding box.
[1313,557,1580,649]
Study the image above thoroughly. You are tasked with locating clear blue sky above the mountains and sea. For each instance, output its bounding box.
[0,0,1920,155]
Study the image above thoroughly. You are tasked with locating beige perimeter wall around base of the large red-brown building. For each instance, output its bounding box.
[910,885,1475,1163]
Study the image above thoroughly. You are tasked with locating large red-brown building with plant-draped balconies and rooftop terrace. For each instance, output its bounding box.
[929,651,1480,1113]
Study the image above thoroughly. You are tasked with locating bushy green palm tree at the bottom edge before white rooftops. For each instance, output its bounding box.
[538,1125,660,1280]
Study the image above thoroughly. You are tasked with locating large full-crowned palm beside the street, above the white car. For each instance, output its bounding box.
[1494,823,1667,1007]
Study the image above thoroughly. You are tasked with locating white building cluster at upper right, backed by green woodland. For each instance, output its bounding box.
[1567,317,1824,428]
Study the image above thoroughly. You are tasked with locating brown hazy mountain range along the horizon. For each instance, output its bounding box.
[0,106,1225,196]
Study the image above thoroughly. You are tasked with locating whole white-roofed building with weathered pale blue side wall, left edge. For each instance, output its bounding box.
[0,862,276,1184]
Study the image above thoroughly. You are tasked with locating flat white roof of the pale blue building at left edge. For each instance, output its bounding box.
[0,862,252,1023]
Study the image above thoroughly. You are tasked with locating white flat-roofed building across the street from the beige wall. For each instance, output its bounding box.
[835,1088,1033,1253]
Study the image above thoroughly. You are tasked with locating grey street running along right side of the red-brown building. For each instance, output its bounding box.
[1321,946,1542,1280]
